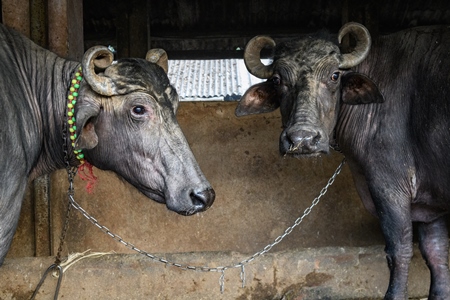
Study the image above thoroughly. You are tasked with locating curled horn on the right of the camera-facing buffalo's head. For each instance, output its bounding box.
[338,22,372,69]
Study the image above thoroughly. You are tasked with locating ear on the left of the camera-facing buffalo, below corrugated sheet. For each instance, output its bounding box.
[235,81,280,117]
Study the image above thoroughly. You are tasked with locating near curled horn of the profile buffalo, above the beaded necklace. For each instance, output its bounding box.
[81,46,117,96]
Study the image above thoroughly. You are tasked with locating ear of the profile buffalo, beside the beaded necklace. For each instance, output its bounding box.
[75,103,100,150]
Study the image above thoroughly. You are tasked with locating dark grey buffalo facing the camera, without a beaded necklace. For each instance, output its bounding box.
[236,23,450,299]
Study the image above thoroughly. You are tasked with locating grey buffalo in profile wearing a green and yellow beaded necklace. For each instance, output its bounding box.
[0,24,215,265]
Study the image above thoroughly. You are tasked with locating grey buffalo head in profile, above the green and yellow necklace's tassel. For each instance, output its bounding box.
[75,47,215,215]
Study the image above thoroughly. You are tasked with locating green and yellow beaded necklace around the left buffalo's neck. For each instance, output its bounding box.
[67,67,85,165]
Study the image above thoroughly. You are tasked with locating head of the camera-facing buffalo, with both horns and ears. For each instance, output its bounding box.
[236,23,383,156]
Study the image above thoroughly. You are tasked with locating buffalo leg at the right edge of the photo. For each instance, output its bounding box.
[418,217,450,300]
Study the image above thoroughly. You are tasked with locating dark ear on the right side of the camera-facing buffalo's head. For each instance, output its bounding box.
[341,72,384,105]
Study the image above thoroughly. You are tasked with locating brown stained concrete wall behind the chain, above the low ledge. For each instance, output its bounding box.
[10,102,383,256]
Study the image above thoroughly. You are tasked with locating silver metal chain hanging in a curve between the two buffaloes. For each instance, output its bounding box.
[69,158,345,293]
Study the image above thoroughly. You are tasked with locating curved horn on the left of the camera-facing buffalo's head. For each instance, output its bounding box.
[244,36,276,79]
